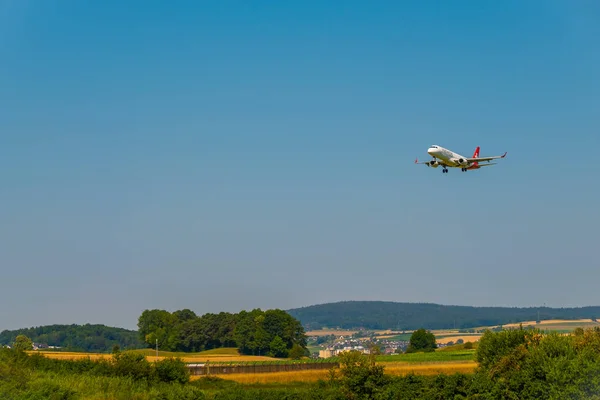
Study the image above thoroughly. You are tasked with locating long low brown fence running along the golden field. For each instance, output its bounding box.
[188,362,339,375]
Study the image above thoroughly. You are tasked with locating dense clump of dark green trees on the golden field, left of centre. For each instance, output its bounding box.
[138,309,307,358]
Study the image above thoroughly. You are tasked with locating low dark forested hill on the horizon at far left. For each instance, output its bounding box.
[0,324,146,353]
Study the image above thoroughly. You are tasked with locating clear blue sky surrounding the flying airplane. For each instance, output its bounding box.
[0,0,600,329]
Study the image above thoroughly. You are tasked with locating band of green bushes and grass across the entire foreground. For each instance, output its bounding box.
[0,328,600,400]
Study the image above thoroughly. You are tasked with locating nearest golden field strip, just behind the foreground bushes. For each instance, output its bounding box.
[197,361,477,384]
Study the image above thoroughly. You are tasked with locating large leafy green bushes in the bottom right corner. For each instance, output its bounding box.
[475,327,600,399]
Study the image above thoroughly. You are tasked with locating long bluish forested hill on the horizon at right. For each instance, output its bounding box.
[287,301,600,330]
